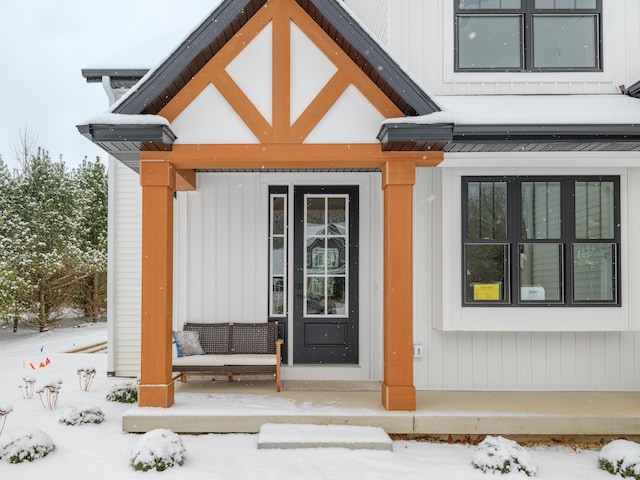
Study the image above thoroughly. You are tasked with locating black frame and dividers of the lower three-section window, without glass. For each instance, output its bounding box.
[460,175,622,308]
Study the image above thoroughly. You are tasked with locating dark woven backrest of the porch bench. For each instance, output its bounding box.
[184,322,278,354]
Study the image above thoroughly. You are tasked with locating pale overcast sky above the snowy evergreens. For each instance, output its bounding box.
[0,0,220,167]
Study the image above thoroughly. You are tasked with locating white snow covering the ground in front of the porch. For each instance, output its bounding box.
[0,324,614,480]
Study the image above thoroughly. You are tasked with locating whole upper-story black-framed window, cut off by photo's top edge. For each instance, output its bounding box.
[454,0,602,72]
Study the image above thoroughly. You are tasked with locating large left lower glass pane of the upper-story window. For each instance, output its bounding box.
[457,15,522,70]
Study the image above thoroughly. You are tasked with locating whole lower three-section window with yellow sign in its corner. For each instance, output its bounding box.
[462,176,620,306]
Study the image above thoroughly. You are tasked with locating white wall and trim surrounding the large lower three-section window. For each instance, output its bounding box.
[414,158,640,391]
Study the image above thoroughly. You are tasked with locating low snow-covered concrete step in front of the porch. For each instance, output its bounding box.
[258,423,393,451]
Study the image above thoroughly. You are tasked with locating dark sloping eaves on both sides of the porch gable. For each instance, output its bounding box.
[113,0,439,115]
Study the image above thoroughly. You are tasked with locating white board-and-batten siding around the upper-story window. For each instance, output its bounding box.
[388,0,640,95]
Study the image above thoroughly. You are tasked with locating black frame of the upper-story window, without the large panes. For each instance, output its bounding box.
[453,0,603,73]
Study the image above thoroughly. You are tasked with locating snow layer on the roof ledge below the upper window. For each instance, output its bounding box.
[385,94,640,125]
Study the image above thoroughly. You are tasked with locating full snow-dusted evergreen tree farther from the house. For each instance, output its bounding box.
[1,149,81,331]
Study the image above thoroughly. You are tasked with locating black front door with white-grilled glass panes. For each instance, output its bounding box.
[293,186,359,364]
